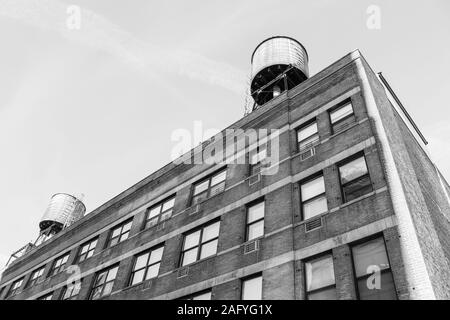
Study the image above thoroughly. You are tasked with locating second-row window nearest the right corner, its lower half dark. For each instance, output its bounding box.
[339,156,372,202]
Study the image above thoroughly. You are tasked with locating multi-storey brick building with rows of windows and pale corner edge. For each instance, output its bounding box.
[0,38,450,300]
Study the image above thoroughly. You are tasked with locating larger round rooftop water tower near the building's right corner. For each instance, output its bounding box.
[250,36,309,110]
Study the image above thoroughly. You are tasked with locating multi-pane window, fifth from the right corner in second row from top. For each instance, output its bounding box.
[130,247,164,286]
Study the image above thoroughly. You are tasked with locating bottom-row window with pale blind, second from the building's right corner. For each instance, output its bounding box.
[305,254,336,300]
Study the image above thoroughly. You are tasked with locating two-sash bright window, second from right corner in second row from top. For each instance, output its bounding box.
[300,176,328,220]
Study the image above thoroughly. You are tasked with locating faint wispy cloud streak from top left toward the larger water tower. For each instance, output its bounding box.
[0,0,246,94]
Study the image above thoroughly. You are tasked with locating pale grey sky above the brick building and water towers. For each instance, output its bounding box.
[0,0,450,271]
